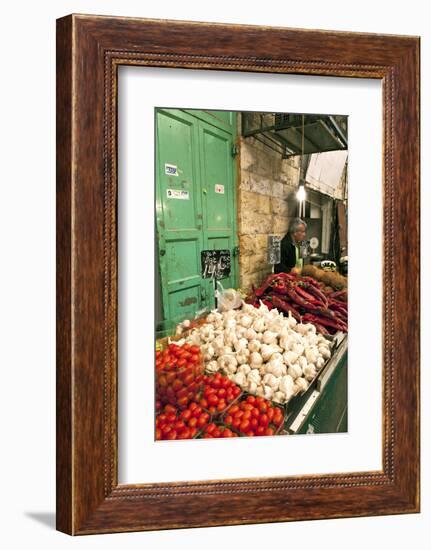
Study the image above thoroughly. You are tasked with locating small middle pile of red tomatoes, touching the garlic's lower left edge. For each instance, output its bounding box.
[196,372,241,415]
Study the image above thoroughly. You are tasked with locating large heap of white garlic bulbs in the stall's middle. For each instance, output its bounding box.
[176,302,331,404]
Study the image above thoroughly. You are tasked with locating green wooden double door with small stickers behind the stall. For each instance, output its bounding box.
[156,109,238,328]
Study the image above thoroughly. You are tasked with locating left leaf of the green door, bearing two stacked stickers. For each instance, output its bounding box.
[156,110,203,321]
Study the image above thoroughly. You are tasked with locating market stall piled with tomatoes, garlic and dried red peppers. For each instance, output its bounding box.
[156,274,347,439]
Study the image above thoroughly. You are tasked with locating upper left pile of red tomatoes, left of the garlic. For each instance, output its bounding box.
[156,344,204,409]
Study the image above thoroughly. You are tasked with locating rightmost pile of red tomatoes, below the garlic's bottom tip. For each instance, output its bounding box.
[223,395,284,437]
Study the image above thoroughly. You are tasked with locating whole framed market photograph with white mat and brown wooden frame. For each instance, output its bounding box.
[57,15,419,535]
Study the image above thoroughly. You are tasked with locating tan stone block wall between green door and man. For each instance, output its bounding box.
[238,117,300,289]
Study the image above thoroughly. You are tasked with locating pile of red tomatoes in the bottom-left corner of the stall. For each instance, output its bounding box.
[156,401,210,440]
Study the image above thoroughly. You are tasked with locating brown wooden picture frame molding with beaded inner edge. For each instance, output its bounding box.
[57,15,419,534]
